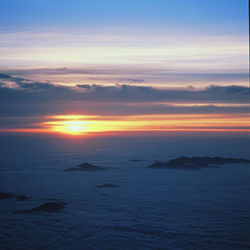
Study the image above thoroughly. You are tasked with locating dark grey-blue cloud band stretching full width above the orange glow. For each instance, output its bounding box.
[0,74,249,116]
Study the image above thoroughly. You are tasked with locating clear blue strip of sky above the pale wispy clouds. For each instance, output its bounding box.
[0,0,248,33]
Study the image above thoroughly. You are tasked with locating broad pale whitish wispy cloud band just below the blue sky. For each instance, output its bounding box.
[0,28,248,73]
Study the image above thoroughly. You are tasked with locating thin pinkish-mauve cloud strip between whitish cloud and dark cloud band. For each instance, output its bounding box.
[2,67,249,86]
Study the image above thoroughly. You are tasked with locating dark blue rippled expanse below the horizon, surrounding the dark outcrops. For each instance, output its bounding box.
[0,133,250,250]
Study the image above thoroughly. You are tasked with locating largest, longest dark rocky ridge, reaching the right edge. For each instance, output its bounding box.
[149,156,250,170]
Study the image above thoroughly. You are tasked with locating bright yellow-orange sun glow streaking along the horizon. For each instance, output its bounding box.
[0,113,250,136]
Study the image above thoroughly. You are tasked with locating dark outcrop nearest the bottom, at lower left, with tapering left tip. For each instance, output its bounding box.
[13,202,65,214]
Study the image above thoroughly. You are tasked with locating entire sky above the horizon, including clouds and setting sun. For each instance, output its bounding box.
[0,0,249,136]
